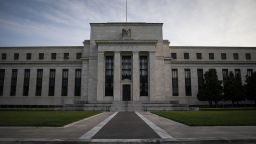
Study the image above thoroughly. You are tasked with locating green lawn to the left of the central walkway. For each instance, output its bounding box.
[0,111,99,127]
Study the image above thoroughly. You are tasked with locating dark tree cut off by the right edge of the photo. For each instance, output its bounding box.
[245,72,256,105]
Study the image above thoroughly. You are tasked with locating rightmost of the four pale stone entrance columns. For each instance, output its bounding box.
[149,52,157,101]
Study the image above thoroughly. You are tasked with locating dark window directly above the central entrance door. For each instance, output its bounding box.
[122,56,132,80]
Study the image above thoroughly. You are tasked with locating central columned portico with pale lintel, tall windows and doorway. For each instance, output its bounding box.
[96,40,157,101]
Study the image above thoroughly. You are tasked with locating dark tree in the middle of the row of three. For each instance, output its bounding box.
[224,72,245,105]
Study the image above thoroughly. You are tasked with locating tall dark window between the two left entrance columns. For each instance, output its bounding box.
[105,56,114,96]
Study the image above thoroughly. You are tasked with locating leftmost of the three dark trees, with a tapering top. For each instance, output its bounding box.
[197,69,223,106]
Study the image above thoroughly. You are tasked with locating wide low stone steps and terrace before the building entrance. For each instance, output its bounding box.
[62,101,198,112]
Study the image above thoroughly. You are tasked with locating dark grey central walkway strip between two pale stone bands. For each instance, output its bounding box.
[93,112,160,139]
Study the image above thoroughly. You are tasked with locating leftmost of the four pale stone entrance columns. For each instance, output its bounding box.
[97,52,105,101]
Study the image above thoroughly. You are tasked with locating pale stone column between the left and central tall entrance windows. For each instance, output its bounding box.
[114,51,121,101]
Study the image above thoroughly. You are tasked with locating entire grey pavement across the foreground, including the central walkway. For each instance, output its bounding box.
[0,112,256,144]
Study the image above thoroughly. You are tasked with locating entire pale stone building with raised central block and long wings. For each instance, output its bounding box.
[0,23,256,105]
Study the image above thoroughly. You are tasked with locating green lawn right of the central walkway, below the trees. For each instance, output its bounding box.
[154,110,256,126]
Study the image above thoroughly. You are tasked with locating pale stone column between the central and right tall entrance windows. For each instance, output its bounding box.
[132,52,140,101]
